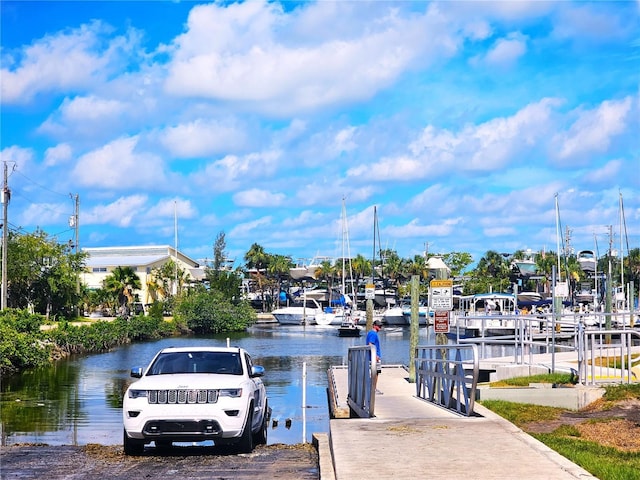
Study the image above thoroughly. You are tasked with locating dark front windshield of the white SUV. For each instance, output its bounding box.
[147,352,242,375]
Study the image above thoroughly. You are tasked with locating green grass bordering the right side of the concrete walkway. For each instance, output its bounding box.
[482,377,640,480]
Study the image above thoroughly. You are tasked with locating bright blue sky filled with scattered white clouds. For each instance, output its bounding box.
[0,0,640,266]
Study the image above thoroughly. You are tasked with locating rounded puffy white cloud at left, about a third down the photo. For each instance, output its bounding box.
[71,136,164,190]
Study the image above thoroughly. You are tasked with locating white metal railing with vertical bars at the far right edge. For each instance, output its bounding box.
[577,329,640,385]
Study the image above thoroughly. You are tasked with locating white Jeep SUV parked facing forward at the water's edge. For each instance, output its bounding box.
[122,347,271,455]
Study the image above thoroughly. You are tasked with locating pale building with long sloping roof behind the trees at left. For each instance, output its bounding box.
[81,245,204,304]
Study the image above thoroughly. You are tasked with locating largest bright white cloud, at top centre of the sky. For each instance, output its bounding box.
[166,2,456,114]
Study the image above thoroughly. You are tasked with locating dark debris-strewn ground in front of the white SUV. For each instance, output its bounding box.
[0,444,319,480]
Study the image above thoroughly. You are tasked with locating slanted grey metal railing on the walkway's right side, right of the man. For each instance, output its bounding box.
[415,345,479,416]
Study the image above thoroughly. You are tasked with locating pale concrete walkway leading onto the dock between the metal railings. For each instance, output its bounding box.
[315,366,596,480]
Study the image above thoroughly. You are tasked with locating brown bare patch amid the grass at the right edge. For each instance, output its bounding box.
[523,399,640,452]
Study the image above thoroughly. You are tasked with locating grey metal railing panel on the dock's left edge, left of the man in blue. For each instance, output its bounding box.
[347,345,378,418]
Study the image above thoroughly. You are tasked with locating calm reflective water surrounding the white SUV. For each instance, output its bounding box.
[0,325,512,445]
